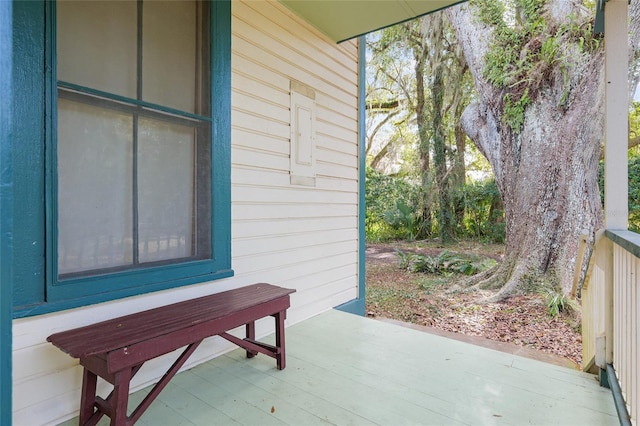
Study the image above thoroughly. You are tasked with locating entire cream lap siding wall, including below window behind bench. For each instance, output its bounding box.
[13,1,358,426]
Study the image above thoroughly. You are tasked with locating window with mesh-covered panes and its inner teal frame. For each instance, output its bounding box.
[39,0,232,302]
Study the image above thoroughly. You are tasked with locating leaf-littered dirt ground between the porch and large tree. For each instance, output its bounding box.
[366,242,582,365]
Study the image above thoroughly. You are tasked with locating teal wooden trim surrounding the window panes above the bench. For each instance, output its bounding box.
[14,0,233,318]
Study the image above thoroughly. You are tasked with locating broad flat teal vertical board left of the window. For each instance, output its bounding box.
[11,1,45,309]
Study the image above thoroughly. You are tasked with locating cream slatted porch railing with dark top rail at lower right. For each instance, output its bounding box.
[581,230,640,424]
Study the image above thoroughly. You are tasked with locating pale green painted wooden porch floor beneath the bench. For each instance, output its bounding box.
[58,310,619,426]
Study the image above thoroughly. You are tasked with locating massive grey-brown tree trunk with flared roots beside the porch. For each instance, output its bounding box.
[447,0,603,300]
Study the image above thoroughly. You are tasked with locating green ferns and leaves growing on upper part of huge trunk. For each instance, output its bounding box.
[471,0,600,133]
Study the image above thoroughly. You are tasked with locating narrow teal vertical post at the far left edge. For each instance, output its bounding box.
[0,1,13,425]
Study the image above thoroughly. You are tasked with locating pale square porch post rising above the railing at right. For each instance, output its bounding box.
[604,0,629,231]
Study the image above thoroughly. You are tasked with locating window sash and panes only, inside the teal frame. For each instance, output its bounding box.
[56,1,211,279]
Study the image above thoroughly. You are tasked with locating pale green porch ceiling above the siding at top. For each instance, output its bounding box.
[280,0,466,42]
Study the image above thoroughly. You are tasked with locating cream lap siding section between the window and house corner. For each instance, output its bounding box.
[231,2,358,317]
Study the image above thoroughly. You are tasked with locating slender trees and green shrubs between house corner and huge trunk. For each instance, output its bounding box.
[366,12,474,245]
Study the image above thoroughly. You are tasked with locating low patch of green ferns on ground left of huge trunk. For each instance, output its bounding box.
[396,250,496,275]
